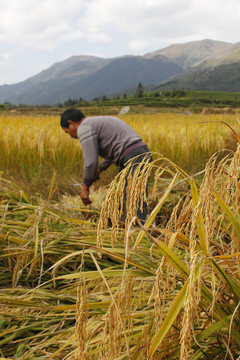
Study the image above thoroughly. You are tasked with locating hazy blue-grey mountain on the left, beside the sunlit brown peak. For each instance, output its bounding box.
[0,55,182,105]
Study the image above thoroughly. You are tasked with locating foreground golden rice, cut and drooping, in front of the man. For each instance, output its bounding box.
[0,112,240,360]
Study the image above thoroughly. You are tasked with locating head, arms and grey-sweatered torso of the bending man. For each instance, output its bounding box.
[61,109,151,220]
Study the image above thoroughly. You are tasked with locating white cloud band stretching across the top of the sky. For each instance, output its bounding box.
[0,0,240,50]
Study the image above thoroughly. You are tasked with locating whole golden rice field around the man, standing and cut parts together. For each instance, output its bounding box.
[0,109,240,360]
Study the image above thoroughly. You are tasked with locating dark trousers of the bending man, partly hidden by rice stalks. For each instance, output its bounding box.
[119,145,152,223]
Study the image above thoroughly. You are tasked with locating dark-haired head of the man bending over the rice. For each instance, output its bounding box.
[60,109,85,138]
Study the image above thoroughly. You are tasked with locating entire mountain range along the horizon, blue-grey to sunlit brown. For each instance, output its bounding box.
[0,40,240,105]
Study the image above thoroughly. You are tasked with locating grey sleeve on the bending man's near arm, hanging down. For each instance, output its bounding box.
[78,125,99,186]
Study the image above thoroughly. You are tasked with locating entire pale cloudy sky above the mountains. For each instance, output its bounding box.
[0,0,240,85]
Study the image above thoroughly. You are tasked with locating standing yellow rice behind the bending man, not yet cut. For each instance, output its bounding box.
[0,113,238,197]
